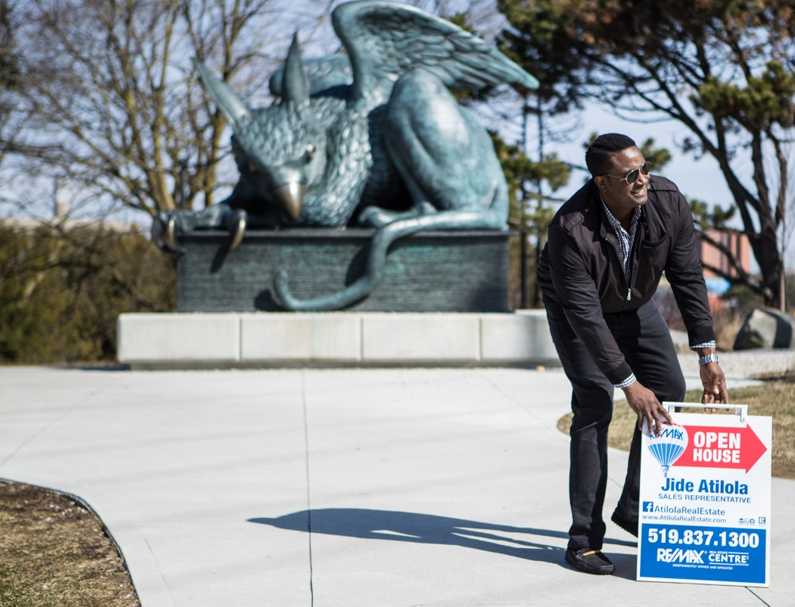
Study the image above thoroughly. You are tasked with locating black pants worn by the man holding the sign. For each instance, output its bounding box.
[547,302,685,550]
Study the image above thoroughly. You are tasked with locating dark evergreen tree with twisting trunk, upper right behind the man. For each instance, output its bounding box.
[498,0,795,307]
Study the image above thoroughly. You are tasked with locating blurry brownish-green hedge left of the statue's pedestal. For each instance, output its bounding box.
[0,222,176,364]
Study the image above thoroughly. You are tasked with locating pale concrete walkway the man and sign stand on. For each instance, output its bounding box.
[0,367,795,607]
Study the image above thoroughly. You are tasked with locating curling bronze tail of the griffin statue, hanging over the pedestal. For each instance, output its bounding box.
[273,180,508,312]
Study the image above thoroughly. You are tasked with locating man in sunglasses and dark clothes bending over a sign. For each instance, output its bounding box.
[538,133,728,574]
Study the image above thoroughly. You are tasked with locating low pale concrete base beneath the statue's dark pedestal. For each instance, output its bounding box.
[118,310,558,368]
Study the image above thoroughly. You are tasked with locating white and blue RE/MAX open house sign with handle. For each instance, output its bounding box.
[637,402,772,586]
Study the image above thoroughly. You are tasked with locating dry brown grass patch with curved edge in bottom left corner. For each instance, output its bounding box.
[0,481,140,607]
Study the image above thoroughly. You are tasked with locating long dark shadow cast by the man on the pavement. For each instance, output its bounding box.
[248,508,635,567]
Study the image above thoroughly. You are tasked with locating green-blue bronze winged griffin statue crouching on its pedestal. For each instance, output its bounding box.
[153,1,538,311]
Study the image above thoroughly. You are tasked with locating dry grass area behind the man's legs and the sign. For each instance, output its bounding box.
[558,377,795,479]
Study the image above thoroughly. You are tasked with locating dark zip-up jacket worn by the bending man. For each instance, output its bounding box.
[538,175,715,384]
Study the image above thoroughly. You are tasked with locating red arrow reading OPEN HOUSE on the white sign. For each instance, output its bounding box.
[673,425,767,473]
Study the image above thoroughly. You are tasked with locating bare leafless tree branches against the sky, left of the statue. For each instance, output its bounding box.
[0,0,336,215]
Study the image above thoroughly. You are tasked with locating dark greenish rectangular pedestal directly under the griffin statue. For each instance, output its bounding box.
[177,228,517,312]
